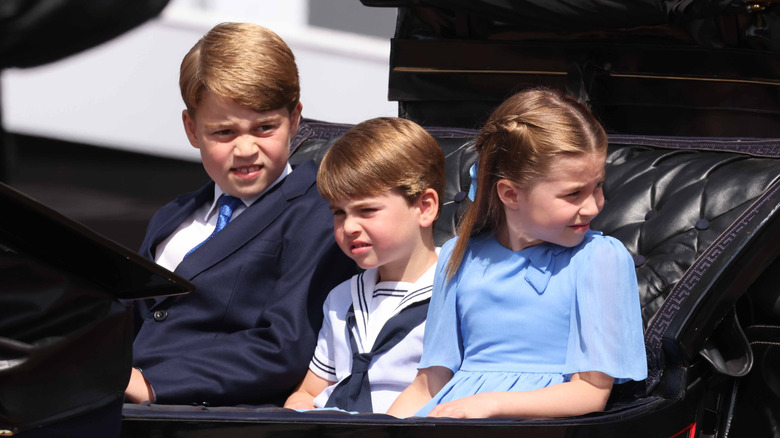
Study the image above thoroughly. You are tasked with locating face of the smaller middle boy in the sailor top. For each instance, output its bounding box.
[330,189,438,281]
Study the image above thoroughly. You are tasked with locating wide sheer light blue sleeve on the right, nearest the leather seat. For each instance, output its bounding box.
[564,235,647,384]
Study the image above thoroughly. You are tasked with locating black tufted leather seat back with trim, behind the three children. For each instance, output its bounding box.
[291,121,780,394]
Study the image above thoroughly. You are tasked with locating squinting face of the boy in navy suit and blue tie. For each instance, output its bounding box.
[182,91,302,197]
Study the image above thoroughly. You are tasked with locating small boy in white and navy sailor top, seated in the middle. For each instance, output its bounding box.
[285,118,445,413]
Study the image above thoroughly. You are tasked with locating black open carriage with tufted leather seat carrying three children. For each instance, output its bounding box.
[0,0,780,438]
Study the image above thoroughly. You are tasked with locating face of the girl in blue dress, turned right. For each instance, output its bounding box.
[497,152,606,251]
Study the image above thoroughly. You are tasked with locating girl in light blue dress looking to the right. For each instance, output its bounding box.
[388,89,647,418]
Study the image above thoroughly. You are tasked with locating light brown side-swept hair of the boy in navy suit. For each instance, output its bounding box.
[179,23,300,116]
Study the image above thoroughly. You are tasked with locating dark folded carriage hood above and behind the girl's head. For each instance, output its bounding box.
[363,0,780,137]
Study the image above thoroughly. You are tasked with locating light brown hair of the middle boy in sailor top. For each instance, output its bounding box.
[317,117,445,216]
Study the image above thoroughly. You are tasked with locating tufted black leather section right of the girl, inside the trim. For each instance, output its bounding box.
[593,144,780,324]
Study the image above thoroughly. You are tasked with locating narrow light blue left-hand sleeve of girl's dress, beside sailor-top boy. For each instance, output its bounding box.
[418,239,465,372]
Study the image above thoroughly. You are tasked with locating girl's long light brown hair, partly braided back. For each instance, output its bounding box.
[447,88,607,279]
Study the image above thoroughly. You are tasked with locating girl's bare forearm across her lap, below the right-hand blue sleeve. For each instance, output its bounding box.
[426,371,614,418]
